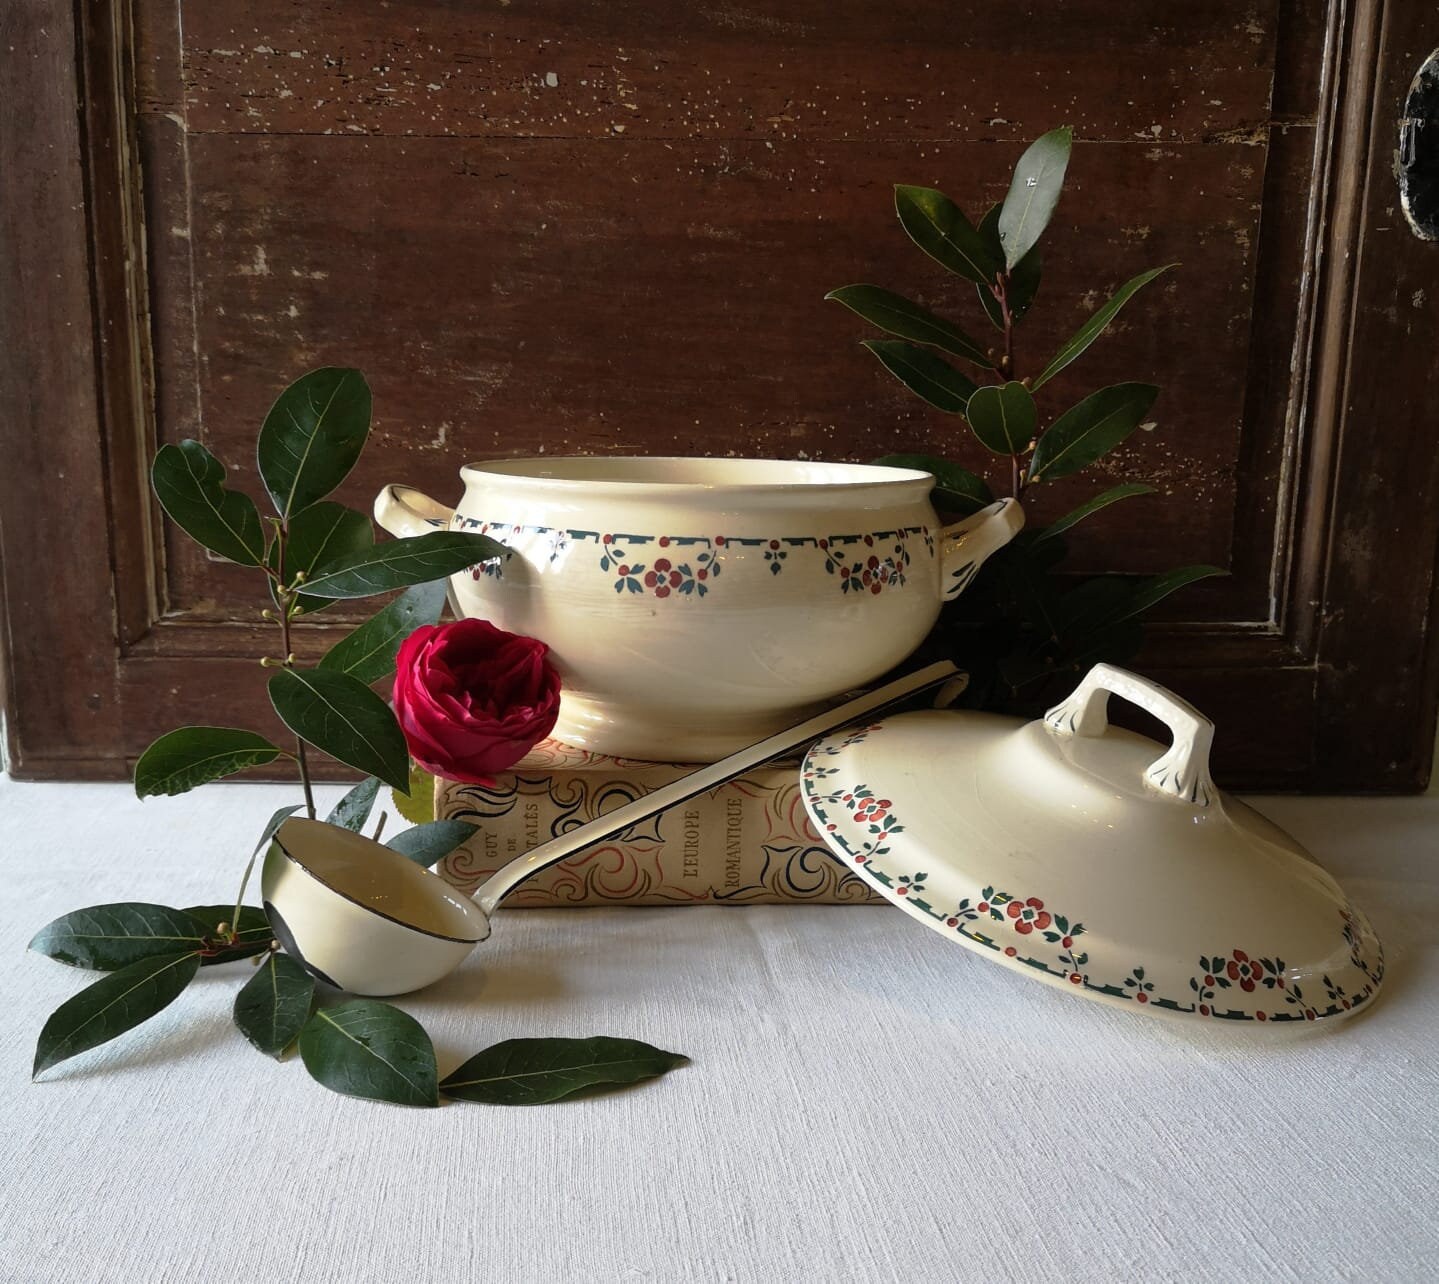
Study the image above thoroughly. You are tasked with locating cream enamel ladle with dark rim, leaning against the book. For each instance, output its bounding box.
[260,661,957,995]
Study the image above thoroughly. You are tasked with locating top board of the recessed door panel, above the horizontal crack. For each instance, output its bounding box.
[141,0,1283,143]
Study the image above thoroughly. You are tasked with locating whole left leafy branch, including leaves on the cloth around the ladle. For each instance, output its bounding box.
[30,369,685,1106]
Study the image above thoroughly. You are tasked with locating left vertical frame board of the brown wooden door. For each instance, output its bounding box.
[0,0,124,776]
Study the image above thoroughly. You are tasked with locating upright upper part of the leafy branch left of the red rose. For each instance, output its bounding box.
[135,367,507,818]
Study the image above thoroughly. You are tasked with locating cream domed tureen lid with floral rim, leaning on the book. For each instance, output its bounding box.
[802,664,1384,1023]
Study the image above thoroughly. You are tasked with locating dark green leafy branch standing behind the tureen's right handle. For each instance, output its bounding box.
[826,128,1223,710]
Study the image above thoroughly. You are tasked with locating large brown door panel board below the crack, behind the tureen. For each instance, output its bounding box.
[160,135,1262,605]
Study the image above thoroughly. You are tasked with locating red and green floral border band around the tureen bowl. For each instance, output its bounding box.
[455,517,934,599]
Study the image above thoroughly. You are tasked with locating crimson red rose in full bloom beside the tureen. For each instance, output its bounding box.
[393,619,560,785]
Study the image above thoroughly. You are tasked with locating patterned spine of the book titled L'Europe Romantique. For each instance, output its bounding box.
[435,767,884,907]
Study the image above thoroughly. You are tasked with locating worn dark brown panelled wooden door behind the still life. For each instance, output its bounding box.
[0,0,1439,790]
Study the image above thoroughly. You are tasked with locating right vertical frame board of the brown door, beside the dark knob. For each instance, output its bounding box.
[1314,6,1439,789]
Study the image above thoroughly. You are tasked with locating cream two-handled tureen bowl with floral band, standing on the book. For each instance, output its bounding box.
[374,456,1023,761]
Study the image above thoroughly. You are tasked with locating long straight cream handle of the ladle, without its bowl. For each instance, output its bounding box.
[475,661,958,914]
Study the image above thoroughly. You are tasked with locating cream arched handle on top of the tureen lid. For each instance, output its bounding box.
[1045,664,1219,808]
